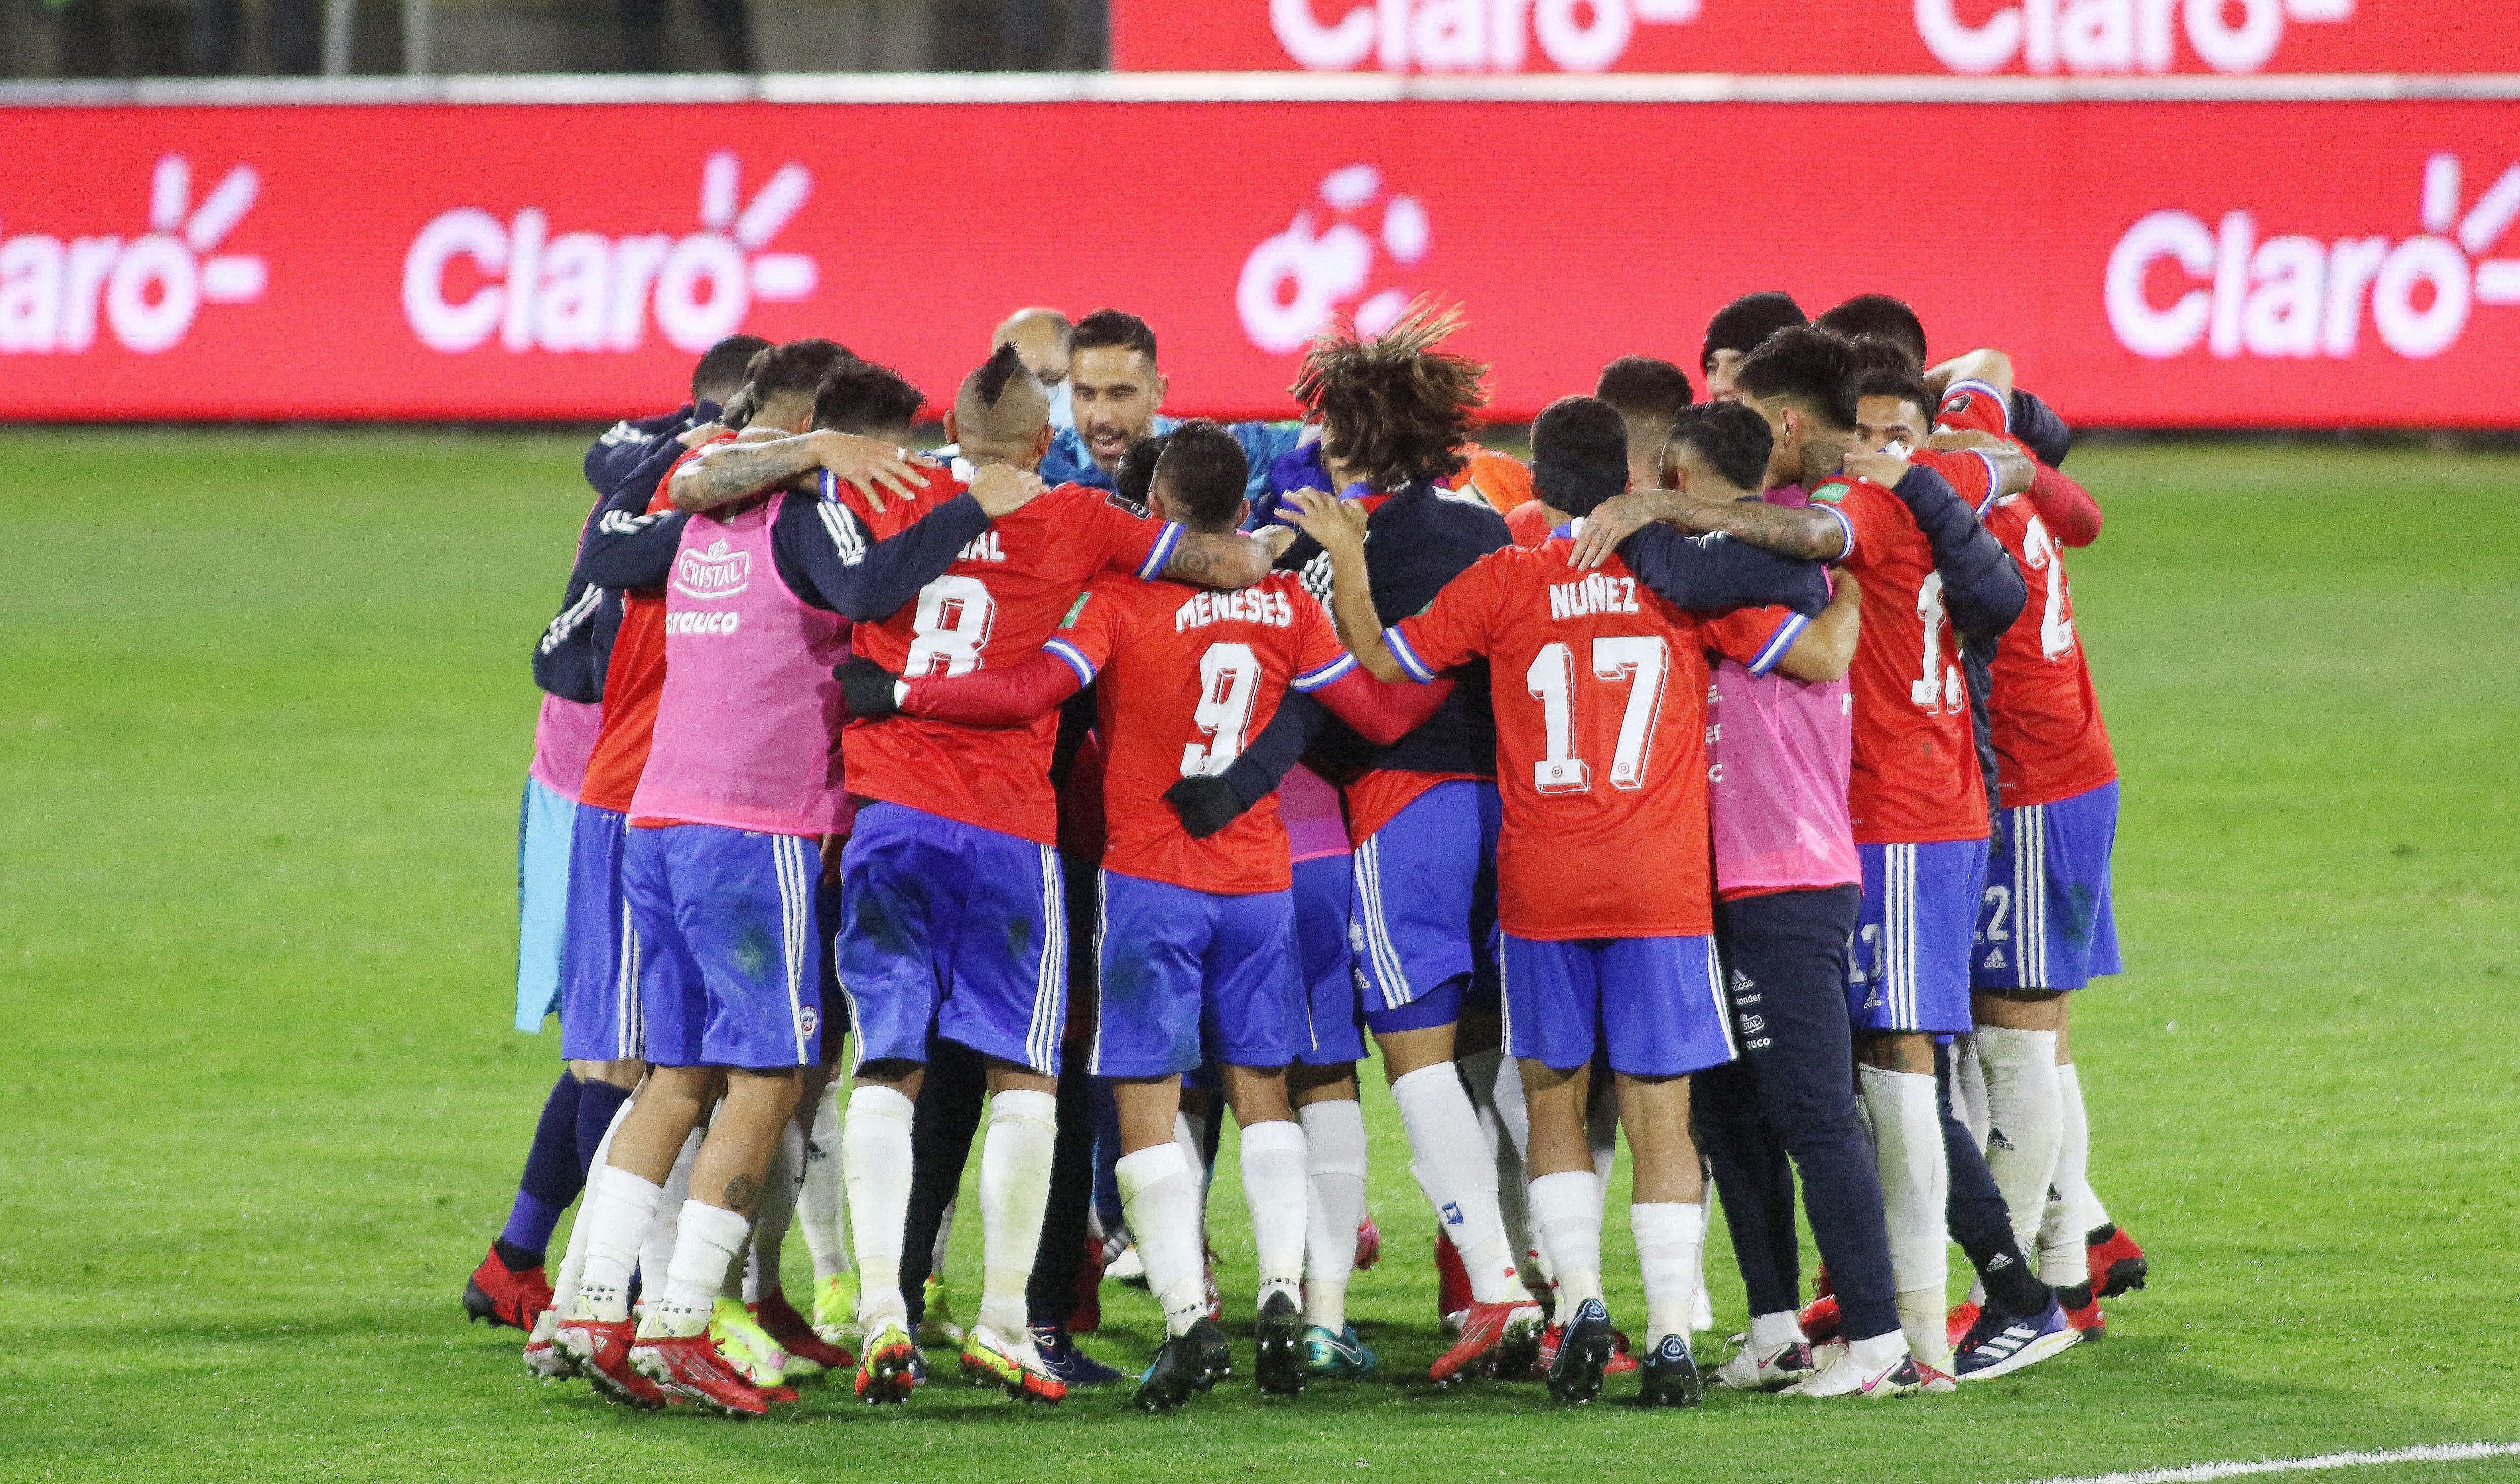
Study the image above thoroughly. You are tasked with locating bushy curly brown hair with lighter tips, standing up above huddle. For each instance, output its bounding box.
[1293,302,1487,494]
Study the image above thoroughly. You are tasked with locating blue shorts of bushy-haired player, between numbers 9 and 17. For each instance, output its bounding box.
[1348,779,1502,1033]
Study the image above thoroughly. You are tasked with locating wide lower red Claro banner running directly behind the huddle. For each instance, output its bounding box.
[0,101,2520,426]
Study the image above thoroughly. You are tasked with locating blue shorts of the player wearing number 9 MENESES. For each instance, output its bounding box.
[1091,872,1313,1078]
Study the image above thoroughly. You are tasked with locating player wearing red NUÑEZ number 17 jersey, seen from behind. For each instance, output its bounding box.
[1298,398,1825,1406]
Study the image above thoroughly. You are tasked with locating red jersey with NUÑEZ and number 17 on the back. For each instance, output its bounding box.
[1383,536,1714,940]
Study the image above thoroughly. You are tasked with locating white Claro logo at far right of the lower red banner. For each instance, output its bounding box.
[2102,154,2520,358]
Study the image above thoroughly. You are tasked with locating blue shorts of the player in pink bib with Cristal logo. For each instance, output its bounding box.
[622,824,821,1071]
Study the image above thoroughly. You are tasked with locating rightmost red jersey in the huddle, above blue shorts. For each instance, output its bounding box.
[1986,494,2117,809]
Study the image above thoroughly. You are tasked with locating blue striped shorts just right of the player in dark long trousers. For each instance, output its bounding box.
[1847,839,1986,1035]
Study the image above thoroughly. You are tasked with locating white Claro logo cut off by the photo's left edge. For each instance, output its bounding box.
[0,154,264,355]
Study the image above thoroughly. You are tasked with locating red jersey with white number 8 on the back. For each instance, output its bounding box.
[839,468,1182,844]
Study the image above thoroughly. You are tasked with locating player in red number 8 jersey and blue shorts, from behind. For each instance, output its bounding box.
[680,345,1273,1401]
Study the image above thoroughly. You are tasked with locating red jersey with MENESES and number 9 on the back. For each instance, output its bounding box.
[1043,572,1356,897]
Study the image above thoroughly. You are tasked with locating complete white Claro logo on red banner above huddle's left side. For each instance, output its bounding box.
[403,151,814,353]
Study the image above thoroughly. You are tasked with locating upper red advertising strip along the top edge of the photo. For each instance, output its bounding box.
[1111,0,2520,76]
